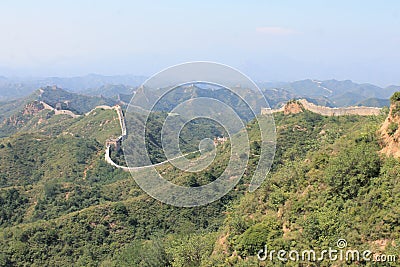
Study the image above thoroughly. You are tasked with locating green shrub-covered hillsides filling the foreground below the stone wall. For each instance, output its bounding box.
[0,97,400,266]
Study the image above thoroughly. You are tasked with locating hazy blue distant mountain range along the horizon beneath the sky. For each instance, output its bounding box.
[0,74,400,108]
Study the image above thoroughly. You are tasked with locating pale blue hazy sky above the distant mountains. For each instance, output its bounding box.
[0,0,400,85]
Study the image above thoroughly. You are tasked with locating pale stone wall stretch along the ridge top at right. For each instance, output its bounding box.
[261,99,381,116]
